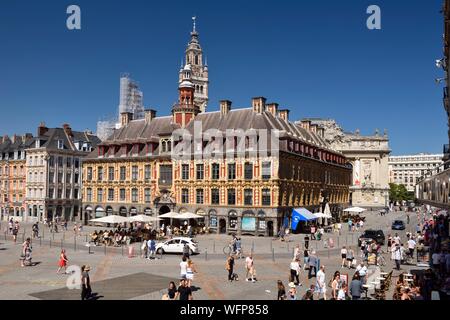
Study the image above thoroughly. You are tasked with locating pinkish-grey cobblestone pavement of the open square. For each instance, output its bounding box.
[0,212,426,300]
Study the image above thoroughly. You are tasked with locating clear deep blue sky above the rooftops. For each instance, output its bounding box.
[0,0,442,154]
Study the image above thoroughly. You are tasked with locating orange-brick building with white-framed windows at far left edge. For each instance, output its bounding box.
[0,133,34,221]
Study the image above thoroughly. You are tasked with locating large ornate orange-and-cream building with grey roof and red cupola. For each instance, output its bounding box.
[83,96,352,236]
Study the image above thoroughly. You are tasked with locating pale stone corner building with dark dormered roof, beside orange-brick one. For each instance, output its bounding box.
[26,123,100,221]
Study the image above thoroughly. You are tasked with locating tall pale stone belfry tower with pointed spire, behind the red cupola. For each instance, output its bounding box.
[178,17,209,112]
